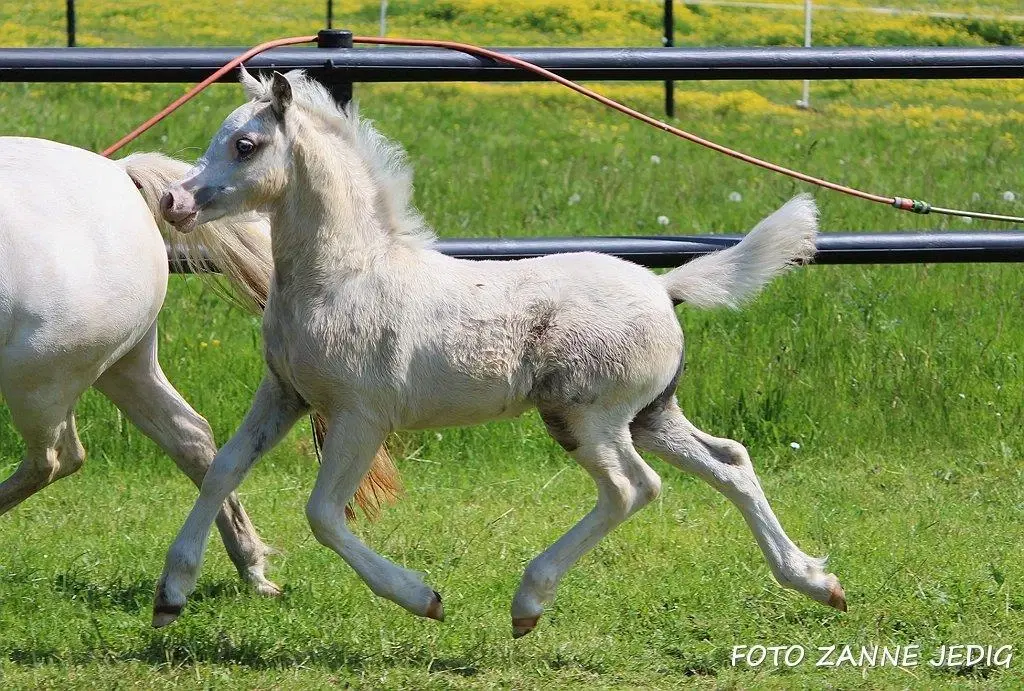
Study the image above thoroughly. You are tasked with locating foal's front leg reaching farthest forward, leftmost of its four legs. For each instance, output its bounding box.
[153,372,309,628]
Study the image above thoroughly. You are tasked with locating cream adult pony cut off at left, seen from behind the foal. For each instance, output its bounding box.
[0,137,390,595]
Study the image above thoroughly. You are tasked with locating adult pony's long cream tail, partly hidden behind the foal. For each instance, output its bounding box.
[115,153,401,518]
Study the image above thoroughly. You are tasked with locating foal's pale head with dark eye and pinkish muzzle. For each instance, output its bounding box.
[160,70,302,232]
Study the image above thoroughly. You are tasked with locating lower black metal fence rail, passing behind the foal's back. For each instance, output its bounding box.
[169,231,1024,273]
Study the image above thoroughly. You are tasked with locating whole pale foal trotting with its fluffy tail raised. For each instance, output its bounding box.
[154,73,846,636]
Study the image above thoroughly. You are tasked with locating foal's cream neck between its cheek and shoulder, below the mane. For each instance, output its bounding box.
[271,120,392,287]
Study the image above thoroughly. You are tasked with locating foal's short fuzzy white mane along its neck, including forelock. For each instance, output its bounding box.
[249,70,436,246]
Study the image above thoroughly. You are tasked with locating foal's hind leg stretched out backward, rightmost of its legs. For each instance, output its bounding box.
[631,398,846,612]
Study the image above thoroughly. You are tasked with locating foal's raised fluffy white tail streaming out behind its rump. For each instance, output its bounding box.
[662,195,818,308]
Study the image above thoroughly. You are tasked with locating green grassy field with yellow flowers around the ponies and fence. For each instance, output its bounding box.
[0,0,1024,689]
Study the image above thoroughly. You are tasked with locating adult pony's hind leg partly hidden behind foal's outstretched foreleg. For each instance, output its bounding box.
[95,325,281,596]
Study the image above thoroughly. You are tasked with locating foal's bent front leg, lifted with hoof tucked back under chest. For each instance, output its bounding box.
[306,413,444,621]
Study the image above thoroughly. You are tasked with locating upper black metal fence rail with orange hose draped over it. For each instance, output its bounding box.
[0,46,1024,83]
